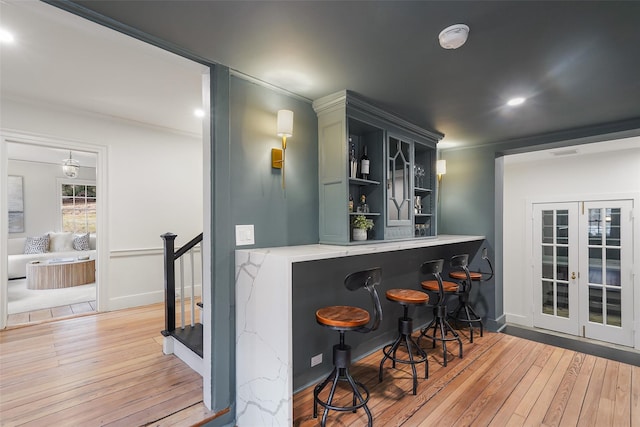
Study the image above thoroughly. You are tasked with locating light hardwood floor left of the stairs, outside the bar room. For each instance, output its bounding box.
[0,304,220,427]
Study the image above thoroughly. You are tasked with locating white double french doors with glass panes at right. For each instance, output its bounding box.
[532,200,633,346]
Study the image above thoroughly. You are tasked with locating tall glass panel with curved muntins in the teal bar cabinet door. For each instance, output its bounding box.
[387,136,413,227]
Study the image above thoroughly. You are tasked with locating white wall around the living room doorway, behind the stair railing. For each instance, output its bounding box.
[0,98,203,310]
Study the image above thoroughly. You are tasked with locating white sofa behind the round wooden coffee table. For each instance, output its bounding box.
[7,233,96,279]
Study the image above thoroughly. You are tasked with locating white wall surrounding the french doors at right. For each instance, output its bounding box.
[503,137,640,344]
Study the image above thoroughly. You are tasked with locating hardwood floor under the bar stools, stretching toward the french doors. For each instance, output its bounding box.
[294,333,640,427]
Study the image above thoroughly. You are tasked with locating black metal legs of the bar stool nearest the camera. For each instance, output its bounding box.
[313,331,373,427]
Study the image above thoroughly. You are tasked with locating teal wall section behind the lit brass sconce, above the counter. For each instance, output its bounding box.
[230,76,319,248]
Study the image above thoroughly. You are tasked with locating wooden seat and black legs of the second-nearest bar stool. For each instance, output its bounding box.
[378,289,429,395]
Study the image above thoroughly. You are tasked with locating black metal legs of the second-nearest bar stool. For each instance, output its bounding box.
[378,305,429,395]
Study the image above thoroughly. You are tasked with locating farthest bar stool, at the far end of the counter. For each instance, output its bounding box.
[449,248,493,342]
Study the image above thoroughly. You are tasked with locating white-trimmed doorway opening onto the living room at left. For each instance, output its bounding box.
[0,137,106,326]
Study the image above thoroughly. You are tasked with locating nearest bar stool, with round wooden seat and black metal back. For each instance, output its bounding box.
[313,267,382,427]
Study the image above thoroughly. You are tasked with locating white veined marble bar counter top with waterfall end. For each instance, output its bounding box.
[235,235,484,427]
